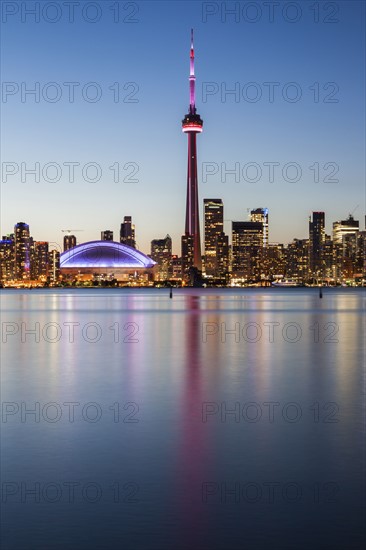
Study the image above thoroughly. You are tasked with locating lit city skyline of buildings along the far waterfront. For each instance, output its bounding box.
[0,208,366,287]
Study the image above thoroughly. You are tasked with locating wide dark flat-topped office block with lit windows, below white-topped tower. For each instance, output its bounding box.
[232,222,263,279]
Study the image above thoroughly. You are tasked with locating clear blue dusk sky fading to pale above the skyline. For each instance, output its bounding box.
[1,0,365,253]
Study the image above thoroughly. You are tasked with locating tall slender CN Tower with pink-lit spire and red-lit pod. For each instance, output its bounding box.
[182,29,203,270]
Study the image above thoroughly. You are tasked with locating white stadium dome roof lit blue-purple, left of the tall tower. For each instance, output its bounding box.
[60,241,156,272]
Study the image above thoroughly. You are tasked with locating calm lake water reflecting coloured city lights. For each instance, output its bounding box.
[1,288,366,550]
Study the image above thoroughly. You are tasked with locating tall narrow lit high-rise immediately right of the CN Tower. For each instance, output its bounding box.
[203,199,224,277]
